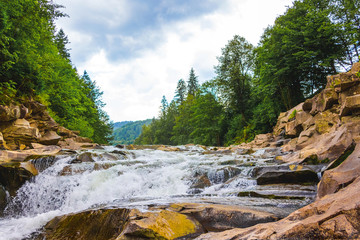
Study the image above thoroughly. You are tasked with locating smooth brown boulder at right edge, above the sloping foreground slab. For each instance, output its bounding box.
[317,144,360,198]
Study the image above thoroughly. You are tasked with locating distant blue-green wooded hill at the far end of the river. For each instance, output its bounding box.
[112,119,152,144]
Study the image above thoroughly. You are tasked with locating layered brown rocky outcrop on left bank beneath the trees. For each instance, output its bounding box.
[0,101,95,150]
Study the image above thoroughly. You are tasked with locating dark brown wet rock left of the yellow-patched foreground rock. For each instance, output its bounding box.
[37,208,130,240]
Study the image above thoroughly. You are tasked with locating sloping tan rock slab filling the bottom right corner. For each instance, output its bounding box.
[196,178,360,240]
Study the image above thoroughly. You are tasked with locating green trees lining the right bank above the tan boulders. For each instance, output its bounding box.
[136,0,360,145]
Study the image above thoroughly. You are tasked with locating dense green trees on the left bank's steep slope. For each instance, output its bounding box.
[0,0,112,143]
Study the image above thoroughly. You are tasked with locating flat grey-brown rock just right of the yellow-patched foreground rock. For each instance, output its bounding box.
[168,203,277,232]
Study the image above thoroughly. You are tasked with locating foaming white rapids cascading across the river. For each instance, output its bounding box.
[0,147,312,239]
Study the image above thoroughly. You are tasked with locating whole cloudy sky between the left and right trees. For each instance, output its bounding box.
[54,0,292,122]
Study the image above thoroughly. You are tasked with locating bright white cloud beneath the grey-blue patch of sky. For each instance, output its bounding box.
[55,0,291,121]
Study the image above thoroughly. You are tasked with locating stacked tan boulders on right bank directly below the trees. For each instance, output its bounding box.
[270,63,360,164]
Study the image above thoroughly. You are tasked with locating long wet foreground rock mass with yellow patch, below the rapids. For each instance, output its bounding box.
[33,203,277,240]
